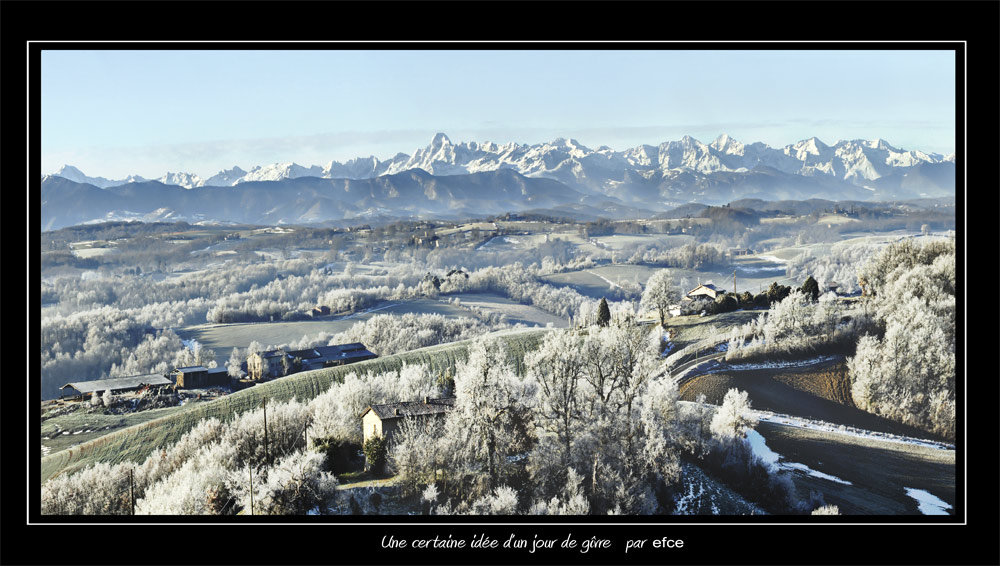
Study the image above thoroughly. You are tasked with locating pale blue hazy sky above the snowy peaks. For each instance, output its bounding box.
[41,46,955,179]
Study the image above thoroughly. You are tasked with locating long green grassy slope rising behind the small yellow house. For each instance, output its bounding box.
[41,330,545,482]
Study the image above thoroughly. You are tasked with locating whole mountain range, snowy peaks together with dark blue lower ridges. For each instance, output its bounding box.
[42,134,955,229]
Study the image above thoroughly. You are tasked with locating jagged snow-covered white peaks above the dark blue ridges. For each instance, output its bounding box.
[48,133,955,194]
